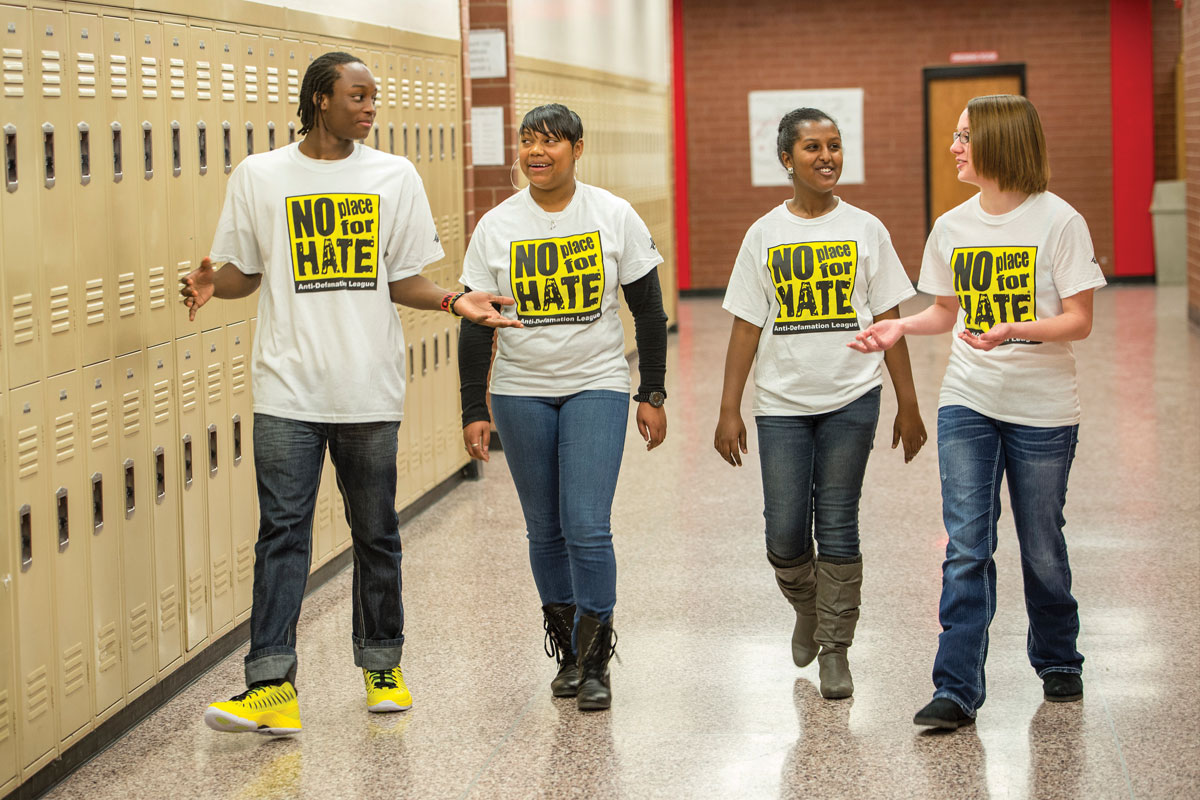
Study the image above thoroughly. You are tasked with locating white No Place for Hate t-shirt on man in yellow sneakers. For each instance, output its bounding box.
[211,144,443,422]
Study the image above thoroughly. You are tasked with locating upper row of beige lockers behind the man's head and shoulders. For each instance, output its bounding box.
[0,4,466,389]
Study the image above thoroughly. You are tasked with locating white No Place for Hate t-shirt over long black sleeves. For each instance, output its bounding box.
[460,182,662,397]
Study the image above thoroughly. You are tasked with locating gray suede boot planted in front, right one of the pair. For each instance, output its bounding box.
[814,559,863,699]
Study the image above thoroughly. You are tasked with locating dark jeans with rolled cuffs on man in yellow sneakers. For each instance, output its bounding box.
[246,414,404,686]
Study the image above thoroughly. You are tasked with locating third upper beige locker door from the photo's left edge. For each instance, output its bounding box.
[68,11,116,365]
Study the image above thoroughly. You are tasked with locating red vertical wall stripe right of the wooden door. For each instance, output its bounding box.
[1108,0,1154,277]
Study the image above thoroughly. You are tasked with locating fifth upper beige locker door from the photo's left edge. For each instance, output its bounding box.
[133,19,171,347]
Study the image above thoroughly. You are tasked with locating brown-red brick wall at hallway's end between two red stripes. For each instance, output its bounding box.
[683,0,1118,288]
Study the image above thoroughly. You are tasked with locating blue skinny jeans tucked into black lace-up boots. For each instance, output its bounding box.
[492,390,629,621]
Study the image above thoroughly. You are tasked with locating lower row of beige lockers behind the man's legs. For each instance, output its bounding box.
[0,312,467,792]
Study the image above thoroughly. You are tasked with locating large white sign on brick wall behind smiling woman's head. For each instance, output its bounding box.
[750,89,866,186]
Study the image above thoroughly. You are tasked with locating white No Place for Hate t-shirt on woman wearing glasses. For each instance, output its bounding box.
[917,192,1105,427]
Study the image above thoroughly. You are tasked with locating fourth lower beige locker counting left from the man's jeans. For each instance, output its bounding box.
[145,344,184,675]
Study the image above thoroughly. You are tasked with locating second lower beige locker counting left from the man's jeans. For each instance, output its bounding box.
[193,327,234,636]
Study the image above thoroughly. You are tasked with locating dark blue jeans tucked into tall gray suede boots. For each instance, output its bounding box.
[755,386,881,564]
